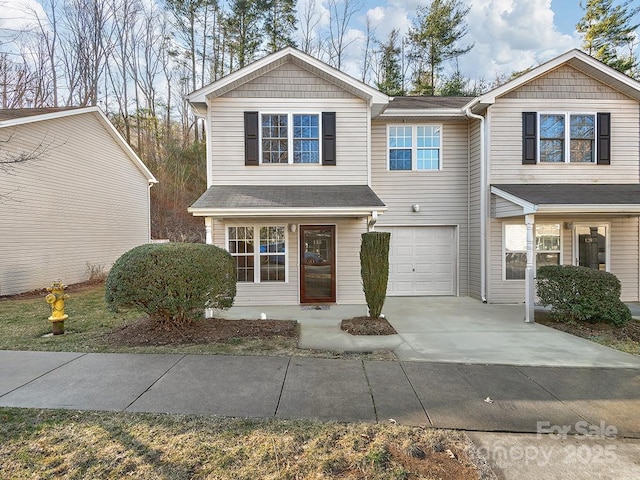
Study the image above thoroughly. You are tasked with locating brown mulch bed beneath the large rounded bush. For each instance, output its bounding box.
[107,317,298,347]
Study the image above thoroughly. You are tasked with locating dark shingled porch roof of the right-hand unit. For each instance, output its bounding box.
[492,183,640,205]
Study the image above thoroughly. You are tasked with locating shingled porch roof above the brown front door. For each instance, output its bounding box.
[191,185,385,209]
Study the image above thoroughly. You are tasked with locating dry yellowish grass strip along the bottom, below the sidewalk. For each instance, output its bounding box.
[0,409,494,480]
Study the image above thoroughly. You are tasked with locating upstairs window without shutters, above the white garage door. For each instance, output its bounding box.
[388,125,442,170]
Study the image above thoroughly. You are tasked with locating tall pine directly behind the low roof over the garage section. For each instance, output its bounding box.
[409,0,473,95]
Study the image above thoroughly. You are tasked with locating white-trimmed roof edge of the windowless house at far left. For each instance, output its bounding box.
[0,107,158,183]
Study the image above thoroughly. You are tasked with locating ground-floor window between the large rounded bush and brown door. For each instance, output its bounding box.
[227,225,286,283]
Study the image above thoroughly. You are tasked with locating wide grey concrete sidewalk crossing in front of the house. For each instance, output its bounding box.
[0,351,640,438]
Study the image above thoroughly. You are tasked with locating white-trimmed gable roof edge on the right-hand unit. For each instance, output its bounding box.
[468,49,640,111]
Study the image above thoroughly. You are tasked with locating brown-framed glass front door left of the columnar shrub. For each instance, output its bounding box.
[300,225,336,303]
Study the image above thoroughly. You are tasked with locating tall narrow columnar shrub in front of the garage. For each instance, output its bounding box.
[360,232,391,318]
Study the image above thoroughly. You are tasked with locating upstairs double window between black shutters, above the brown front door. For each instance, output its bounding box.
[261,113,320,163]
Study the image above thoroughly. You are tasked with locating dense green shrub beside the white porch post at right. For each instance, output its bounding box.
[537,265,631,325]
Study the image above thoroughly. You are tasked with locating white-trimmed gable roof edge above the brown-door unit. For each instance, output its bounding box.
[185,47,389,116]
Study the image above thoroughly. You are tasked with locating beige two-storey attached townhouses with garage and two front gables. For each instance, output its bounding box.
[188,48,640,319]
